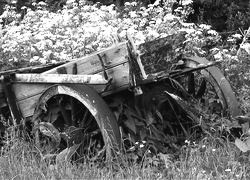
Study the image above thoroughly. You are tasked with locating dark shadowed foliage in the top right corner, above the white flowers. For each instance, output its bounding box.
[188,0,250,32]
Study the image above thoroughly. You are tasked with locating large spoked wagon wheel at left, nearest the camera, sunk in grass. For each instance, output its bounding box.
[33,85,121,161]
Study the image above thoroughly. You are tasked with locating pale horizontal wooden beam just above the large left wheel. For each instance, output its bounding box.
[11,74,108,84]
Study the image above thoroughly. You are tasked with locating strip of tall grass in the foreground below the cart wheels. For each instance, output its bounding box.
[0,127,250,180]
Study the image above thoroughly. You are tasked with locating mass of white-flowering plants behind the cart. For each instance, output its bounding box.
[0,1,209,70]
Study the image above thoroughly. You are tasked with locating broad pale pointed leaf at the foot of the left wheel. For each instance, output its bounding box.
[56,143,81,164]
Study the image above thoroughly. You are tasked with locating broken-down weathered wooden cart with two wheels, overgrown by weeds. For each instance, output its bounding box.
[0,35,239,160]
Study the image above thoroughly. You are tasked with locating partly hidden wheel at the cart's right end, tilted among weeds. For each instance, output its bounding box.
[174,57,240,117]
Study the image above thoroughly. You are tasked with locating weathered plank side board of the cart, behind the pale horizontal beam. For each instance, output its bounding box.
[10,42,129,118]
